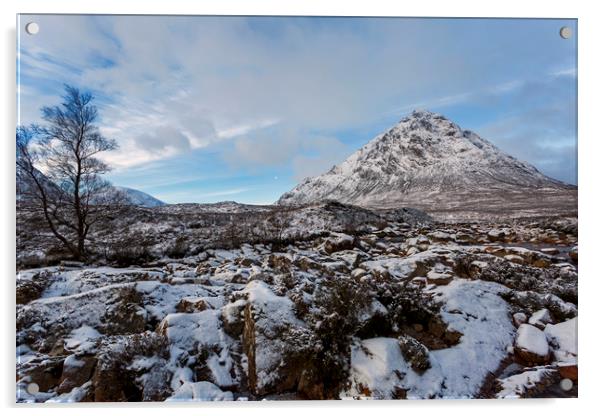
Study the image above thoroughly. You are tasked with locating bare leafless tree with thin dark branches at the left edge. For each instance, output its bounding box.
[17,85,121,259]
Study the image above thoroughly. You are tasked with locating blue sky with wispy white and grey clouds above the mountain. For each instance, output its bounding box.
[18,15,577,203]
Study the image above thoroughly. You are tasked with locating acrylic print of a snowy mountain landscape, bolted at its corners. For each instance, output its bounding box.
[16,14,578,403]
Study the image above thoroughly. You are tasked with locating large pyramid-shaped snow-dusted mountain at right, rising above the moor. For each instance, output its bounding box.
[278,111,577,218]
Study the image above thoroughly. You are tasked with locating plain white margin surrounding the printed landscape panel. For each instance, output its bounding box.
[0,0,602,415]
